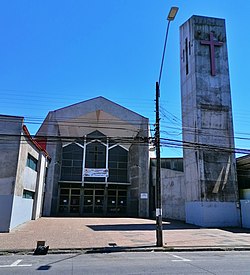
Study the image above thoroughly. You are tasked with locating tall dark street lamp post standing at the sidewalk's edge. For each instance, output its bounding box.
[155,7,178,247]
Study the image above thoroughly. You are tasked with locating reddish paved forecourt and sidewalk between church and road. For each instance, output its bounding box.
[0,217,250,253]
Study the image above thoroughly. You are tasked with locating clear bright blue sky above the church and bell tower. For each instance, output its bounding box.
[0,0,250,157]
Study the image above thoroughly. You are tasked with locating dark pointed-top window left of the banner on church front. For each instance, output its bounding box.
[61,143,83,181]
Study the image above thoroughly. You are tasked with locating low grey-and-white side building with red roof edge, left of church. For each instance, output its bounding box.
[0,115,49,232]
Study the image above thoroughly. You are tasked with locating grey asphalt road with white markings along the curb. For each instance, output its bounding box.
[0,251,250,275]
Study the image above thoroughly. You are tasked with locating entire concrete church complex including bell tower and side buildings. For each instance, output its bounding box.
[0,16,250,232]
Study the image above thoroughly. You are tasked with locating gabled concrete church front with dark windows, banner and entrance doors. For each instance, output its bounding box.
[36,97,149,217]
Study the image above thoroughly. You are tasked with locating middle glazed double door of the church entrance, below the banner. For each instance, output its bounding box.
[83,188,104,215]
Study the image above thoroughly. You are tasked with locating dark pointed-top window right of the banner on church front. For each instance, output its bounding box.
[108,145,128,182]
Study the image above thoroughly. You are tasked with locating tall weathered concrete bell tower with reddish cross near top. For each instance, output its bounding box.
[180,16,240,227]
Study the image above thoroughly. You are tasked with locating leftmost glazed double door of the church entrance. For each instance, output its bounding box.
[59,188,80,216]
